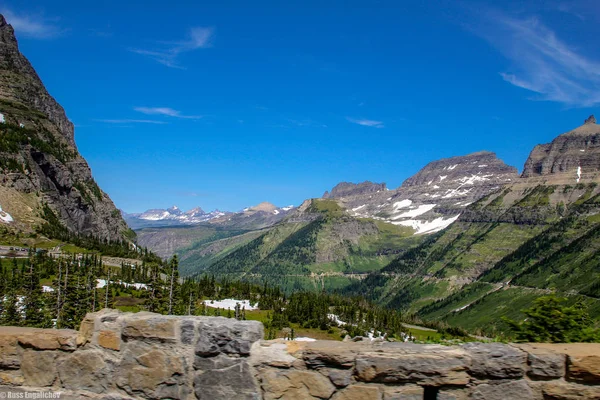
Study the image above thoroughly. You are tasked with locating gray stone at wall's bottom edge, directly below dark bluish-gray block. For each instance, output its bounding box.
[194,362,261,400]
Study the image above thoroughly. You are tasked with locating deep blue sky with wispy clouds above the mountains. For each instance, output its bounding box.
[0,0,600,212]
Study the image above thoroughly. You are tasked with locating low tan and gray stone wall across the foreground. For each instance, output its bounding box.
[0,310,600,400]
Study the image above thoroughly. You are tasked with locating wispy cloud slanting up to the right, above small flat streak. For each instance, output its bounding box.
[130,27,215,68]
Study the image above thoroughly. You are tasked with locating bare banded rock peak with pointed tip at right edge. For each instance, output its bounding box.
[522,115,600,183]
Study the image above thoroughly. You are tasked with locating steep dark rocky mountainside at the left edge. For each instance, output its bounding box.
[0,16,128,240]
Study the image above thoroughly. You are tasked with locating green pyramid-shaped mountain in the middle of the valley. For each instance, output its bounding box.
[199,200,421,290]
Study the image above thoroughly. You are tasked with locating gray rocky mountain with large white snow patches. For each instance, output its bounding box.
[326,151,518,233]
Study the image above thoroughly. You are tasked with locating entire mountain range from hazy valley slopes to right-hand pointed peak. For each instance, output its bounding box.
[132,117,600,336]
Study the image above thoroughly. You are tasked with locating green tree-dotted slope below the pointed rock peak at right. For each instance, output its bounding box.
[350,184,600,333]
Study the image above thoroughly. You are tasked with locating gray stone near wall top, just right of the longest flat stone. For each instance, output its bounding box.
[462,343,527,379]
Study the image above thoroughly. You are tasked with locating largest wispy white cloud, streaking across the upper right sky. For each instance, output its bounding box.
[476,12,600,107]
